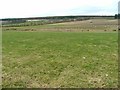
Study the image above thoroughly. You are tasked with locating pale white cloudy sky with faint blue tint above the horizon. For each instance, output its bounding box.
[0,0,119,18]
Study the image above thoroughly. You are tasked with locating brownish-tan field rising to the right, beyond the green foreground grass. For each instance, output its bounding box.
[3,19,118,32]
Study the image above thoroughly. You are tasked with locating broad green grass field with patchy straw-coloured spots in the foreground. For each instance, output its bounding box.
[2,18,118,88]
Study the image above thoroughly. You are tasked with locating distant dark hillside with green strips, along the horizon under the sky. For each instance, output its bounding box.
[0,15,115,26]
